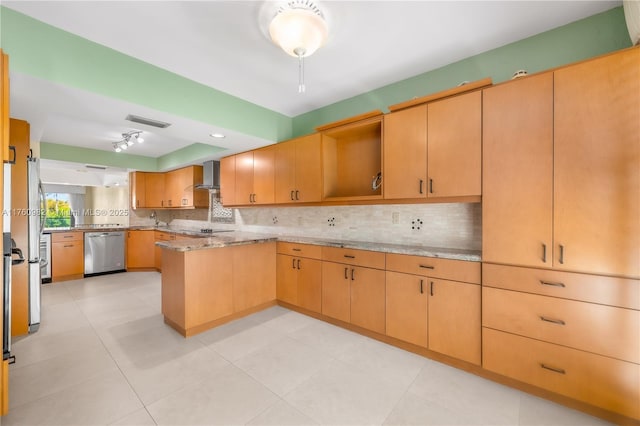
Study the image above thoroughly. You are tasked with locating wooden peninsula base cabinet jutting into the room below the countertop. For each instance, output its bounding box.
[162,242,276,337]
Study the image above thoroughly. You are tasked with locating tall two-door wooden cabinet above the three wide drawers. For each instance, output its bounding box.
[482,48,640,277]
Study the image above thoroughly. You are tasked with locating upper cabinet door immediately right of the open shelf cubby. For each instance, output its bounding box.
[382,105,427,199]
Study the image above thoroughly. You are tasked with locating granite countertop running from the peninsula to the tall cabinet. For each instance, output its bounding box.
[156,231,482,262]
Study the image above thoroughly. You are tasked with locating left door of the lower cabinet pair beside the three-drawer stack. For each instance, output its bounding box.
[386,271,427,348]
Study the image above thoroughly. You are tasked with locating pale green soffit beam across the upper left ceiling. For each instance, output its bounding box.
[0,6,291,141]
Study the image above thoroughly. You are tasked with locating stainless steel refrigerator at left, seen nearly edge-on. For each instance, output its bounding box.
[27,155,46,333]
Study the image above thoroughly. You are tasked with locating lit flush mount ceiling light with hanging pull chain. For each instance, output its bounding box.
[269,0,329,93]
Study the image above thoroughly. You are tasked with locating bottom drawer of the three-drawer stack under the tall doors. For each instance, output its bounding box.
[482,328,640,419]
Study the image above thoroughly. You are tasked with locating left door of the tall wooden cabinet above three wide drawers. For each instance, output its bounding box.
[482,73,553,267]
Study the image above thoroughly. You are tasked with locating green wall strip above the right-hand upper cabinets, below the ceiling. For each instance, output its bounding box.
[293,6,631,137]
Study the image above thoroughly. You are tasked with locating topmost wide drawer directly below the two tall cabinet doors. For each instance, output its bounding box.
[482,263,640,309]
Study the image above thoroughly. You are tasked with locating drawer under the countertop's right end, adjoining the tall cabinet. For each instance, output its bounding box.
[387,254,480,284]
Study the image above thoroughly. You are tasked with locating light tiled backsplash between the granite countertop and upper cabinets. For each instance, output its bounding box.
[136,195,482,250]
